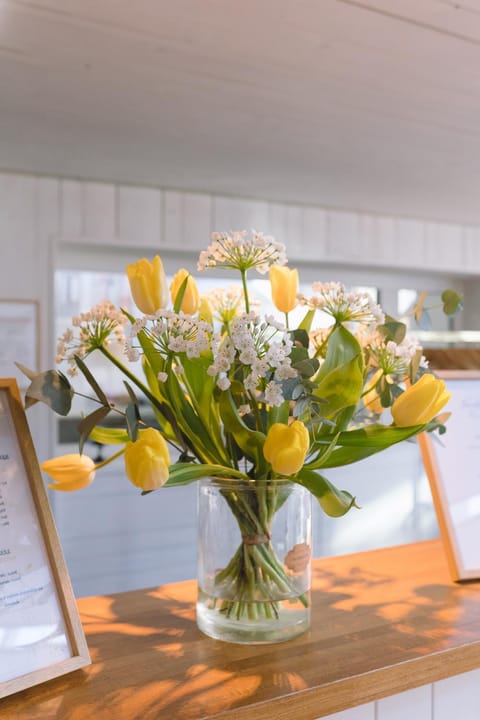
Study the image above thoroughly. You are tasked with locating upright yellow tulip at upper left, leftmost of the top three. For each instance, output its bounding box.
[127,255,168,315]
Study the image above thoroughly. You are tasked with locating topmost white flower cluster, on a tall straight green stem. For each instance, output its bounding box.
[198,230,287,275]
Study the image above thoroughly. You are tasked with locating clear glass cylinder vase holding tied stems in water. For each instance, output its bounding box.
[197,478,311,644]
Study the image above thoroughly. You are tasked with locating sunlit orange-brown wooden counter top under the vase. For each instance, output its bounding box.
[0,541,480,720]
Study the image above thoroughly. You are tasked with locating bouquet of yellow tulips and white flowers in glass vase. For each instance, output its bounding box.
[22,231,460,641]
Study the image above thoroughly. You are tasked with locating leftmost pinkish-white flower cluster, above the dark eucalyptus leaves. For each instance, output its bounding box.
[55,300,128,376]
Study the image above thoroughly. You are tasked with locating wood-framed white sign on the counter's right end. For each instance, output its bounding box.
[418,370,480,580]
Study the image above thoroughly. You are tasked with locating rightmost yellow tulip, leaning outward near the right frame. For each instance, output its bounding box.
[392,374,450,427]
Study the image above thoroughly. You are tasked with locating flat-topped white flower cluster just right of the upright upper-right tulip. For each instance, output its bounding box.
[298,282,385,325]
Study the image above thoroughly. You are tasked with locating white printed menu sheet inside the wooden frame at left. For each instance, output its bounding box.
[0,390,72,682]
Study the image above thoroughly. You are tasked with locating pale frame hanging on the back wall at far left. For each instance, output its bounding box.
[0,300,40,387]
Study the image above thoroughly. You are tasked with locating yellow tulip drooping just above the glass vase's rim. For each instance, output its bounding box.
[263,420,310,476]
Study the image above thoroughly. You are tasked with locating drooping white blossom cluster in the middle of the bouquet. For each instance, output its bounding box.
[207,313,297,406]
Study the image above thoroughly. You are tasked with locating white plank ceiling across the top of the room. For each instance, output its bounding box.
[0,0,480,223]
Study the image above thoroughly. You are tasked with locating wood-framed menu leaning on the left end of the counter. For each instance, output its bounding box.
[0,378,90,697]
